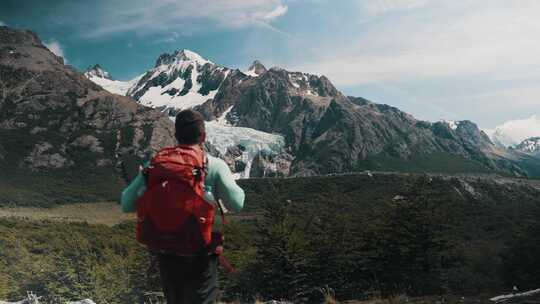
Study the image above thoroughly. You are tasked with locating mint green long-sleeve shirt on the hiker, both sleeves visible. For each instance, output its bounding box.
[120,156,245,212]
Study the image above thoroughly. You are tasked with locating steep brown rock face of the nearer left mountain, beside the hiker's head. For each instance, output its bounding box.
[0,27,174,201]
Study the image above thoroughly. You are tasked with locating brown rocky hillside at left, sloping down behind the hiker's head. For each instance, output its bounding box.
[0,26,174,205]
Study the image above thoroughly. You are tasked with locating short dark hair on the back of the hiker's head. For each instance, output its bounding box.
[174,110,206,145]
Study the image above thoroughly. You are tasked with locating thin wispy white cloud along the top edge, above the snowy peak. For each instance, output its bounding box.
[81,0,288,37]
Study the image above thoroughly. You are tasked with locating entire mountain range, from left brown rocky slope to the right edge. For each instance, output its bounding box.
[0,27,540,207]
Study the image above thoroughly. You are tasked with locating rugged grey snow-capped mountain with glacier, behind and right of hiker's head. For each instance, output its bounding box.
[80,50,540,177]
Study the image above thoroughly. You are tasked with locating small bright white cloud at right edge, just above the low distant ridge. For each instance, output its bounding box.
[486,115,540,146]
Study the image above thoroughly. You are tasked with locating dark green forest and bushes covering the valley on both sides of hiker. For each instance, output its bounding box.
[0,175,540,303]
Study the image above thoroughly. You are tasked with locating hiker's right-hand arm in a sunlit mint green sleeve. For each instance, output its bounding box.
[215,159,245,212]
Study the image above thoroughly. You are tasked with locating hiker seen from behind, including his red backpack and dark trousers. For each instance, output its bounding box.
[121,110,244,304]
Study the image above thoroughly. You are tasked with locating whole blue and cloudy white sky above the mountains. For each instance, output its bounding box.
[0,0,540,136]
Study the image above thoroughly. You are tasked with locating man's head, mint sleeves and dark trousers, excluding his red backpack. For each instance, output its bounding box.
[121,110,245,304]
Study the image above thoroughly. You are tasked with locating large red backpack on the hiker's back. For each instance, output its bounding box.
[137,145,219,255]
